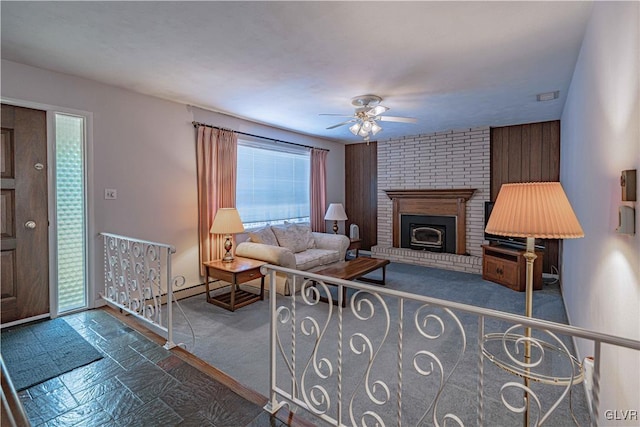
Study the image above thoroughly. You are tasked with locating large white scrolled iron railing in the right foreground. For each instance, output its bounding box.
[262,265,640,426]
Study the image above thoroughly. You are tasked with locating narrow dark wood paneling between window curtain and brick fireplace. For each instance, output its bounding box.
[344,142,378,251]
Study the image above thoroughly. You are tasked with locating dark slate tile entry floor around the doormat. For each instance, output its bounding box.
[12,309,300,427]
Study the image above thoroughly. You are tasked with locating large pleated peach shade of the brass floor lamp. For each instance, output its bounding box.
[485,182,584,239]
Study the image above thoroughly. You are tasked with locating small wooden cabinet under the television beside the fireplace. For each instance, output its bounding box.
[482,245,544,292]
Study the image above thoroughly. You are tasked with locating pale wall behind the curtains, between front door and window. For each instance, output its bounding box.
[1,60,344,306]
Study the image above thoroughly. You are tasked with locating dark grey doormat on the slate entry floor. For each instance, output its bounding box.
[0,318,103,391]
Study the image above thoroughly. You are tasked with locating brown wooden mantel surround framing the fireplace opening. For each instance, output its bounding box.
[384,188,476,255]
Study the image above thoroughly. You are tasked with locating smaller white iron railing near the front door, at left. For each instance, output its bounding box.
[100,233,184,349]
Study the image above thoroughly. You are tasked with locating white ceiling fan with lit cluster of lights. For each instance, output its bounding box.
[320,95,416,141]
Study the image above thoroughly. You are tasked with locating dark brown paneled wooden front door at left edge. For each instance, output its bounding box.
[0,104,49,324]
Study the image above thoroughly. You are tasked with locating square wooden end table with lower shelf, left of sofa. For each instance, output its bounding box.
[203,257,267,311]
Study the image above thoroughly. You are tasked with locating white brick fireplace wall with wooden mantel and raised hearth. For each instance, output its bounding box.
[371,127,490,274]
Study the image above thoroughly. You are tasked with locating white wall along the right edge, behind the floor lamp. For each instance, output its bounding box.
[560,2,640,425]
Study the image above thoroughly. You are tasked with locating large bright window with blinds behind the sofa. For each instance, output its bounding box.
[236,140,311,228]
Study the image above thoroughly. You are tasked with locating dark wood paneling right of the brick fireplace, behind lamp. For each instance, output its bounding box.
[491,120,560,273]
